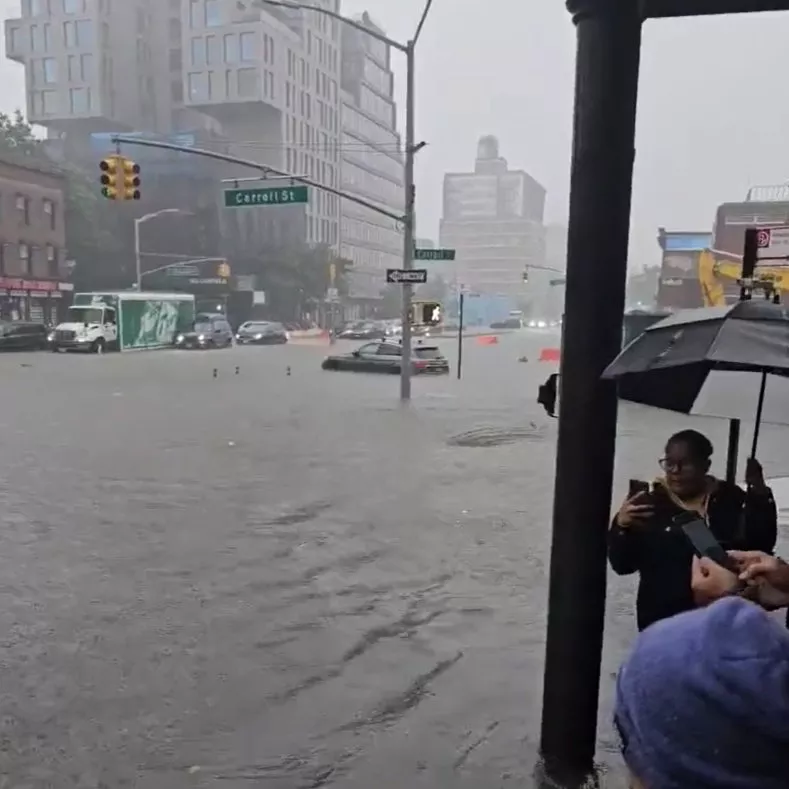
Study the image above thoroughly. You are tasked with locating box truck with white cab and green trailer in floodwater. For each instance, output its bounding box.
[50,291,195,353]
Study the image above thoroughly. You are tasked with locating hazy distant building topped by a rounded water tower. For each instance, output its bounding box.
[440,136,545,299]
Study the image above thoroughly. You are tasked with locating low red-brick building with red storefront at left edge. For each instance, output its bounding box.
[0,152,72,323]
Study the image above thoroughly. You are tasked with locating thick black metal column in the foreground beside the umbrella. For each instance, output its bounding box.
[541,0,642,784]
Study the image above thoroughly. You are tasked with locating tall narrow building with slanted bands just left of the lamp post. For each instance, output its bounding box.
[340,13,405,303]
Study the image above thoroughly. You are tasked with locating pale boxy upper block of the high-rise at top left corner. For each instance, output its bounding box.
[5,0,180,136]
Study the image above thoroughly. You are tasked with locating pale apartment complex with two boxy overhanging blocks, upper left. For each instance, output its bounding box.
[5,0,340,247]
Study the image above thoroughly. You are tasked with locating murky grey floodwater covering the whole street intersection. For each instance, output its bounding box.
[0,332,789,789]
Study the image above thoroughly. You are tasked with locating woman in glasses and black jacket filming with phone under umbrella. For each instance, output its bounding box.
[608,430,778,630]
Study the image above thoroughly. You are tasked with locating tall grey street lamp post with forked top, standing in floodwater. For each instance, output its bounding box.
[251,0,433,401]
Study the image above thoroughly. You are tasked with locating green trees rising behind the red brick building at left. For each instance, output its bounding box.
[0,110,119,285]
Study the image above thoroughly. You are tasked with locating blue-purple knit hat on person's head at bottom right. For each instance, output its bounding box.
[614,598,789,789]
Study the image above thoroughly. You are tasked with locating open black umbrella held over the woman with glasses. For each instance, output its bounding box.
[603,300,789,454]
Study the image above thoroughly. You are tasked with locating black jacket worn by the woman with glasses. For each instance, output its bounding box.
[608,482,778,630]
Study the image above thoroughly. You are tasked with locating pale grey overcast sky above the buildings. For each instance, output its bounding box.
[0,0,789,268]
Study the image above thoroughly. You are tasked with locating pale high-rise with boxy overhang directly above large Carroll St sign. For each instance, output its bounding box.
[186,0,340,248]
